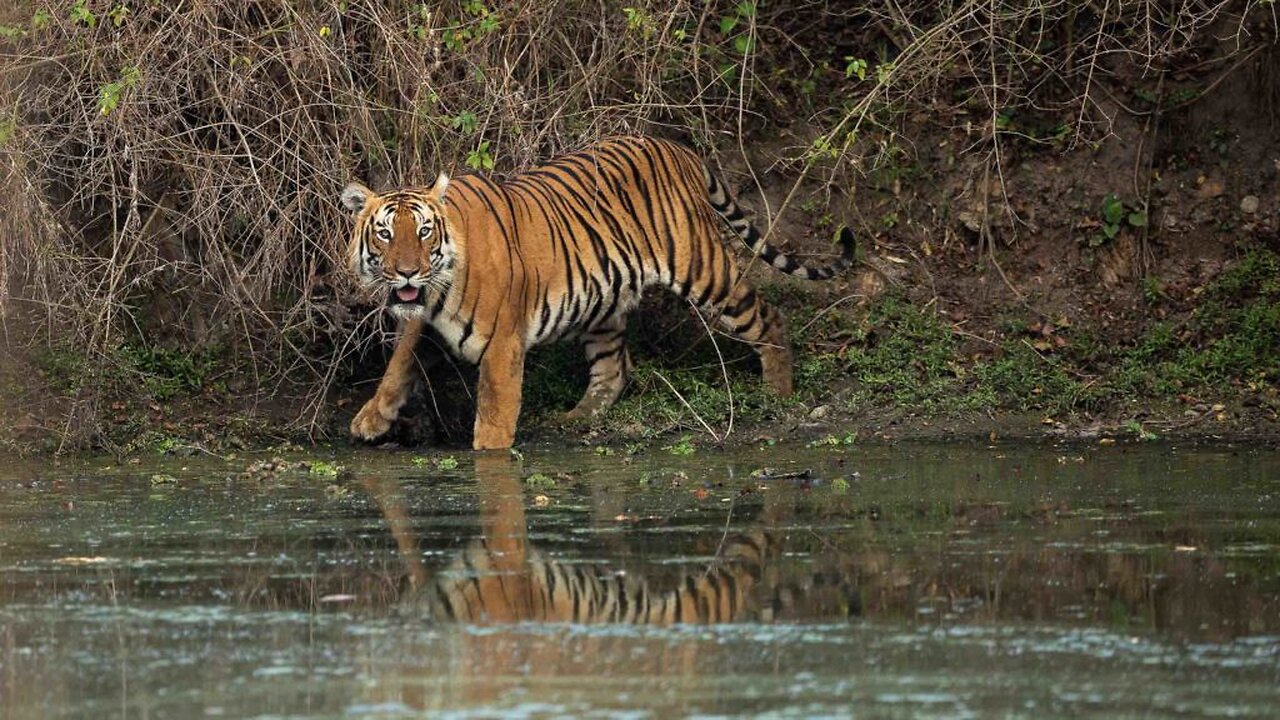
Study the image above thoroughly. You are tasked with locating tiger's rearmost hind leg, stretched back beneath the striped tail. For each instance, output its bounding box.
[682,269,792,397]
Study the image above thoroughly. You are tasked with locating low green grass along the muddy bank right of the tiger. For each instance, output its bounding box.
[566,250,1280,433]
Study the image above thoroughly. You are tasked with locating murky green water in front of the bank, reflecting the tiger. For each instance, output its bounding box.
[0,446,1280,717]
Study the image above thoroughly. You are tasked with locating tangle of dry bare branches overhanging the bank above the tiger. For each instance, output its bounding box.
[0,0,1274,443]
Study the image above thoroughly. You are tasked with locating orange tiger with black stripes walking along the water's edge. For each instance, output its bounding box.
[340,137,856,450]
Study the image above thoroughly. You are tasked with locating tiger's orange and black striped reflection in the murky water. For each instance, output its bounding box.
[365,452,859,625]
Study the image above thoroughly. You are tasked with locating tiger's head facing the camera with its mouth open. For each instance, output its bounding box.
[342,173,457,316]
